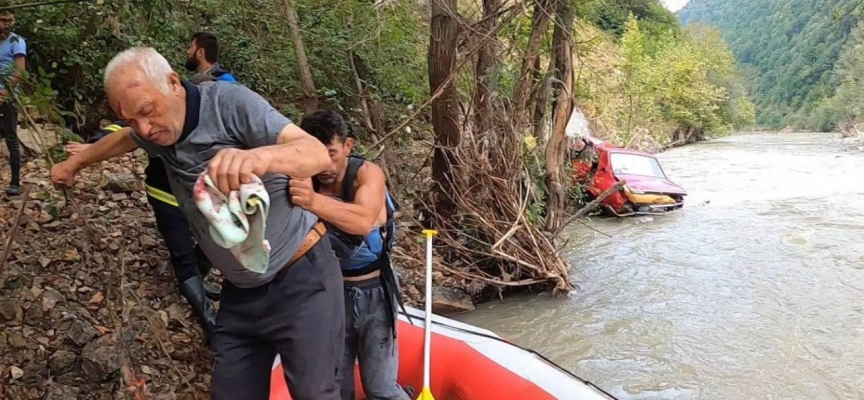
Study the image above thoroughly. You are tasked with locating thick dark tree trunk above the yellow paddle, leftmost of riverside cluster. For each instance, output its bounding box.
[428,0,462,220]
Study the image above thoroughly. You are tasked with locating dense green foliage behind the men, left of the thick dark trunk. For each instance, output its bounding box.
[14,0,428,135]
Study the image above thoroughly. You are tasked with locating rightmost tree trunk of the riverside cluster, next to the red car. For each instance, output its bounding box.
[545,0,573,232]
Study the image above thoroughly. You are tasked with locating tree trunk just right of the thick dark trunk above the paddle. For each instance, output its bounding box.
[474,0,501,136]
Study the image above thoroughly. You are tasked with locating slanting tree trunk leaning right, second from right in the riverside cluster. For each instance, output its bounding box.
[513,0,550,132]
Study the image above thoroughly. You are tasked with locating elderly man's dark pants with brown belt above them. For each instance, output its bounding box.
[211,240,345,400]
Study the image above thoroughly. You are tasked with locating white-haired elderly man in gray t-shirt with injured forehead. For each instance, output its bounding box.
[51,48,344,400]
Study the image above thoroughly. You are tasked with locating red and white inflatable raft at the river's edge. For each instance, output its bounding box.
[270,307,615,400]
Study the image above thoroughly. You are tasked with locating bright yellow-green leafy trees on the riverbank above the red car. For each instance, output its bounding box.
[619,17,753,140]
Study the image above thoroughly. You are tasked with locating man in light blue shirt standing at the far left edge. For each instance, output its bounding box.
[0,10,27,196]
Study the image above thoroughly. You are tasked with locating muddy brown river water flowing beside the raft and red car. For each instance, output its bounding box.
[456,134,864,400]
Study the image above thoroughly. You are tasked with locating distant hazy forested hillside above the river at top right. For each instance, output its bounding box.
[678,0,861,129]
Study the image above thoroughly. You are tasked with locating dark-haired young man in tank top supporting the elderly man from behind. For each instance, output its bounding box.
[289,110,413,400]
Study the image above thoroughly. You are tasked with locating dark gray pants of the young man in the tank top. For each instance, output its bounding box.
[339,278,411,400]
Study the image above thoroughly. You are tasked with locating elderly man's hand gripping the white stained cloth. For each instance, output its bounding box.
[207,149,270,196]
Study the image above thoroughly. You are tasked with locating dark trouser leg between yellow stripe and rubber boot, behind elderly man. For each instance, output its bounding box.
[147,196,198,283]
